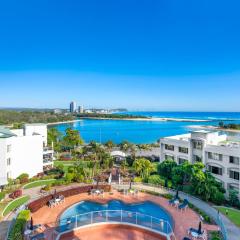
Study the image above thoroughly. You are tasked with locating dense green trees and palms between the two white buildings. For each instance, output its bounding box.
[49,129,232,205]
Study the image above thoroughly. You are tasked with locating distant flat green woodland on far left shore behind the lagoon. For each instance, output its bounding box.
[0,110,76,128]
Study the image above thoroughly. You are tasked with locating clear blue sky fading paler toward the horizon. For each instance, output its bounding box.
[0,0,240,111]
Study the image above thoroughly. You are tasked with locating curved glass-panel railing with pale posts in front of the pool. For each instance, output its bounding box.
[55,210,175,239]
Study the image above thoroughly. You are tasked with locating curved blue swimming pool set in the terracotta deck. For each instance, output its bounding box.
[58,200,173,233]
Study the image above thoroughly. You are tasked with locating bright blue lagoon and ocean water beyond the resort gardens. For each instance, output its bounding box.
[51,112,240,143]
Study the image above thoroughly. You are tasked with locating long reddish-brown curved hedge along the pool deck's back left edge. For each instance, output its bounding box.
[28,185,111,213]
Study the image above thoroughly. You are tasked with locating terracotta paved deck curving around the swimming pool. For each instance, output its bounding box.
[32,190,219,240]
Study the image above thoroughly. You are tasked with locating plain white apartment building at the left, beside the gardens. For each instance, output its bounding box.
[0,124,54,186]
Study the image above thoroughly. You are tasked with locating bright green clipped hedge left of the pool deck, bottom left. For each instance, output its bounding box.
[8,210,30,240]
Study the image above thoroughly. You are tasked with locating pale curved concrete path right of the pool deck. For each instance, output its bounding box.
[129,184,240,240]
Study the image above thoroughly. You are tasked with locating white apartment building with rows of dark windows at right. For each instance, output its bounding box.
[160,130,240,197]
